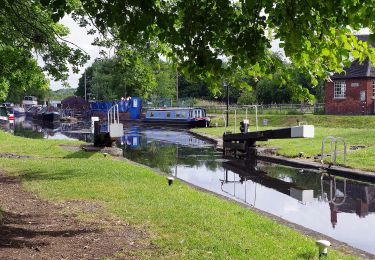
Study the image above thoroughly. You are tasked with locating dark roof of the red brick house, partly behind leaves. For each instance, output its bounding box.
[331,35,375,80]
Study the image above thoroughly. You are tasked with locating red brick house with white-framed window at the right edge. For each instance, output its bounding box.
[325,35,375,115]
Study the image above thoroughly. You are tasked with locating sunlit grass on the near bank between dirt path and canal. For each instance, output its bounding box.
[0,131,351,259]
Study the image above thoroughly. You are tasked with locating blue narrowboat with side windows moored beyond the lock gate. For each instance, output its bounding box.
[142,108,210,127]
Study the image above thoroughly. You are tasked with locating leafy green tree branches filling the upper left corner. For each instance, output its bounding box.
[0,0,88,100]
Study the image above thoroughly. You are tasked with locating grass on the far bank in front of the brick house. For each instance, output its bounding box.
[193,115,375,171]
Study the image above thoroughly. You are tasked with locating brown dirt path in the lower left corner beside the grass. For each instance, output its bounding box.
[0,171,153,259]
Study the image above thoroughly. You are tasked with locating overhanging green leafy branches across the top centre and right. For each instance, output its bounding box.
[43,0,375,87]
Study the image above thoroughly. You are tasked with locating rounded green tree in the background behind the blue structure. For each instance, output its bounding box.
[76,46,157,100]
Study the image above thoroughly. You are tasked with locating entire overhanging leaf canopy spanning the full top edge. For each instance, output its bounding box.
[0,0,375,102]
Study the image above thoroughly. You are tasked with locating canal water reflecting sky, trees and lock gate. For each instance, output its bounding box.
[2,118,375,254]
